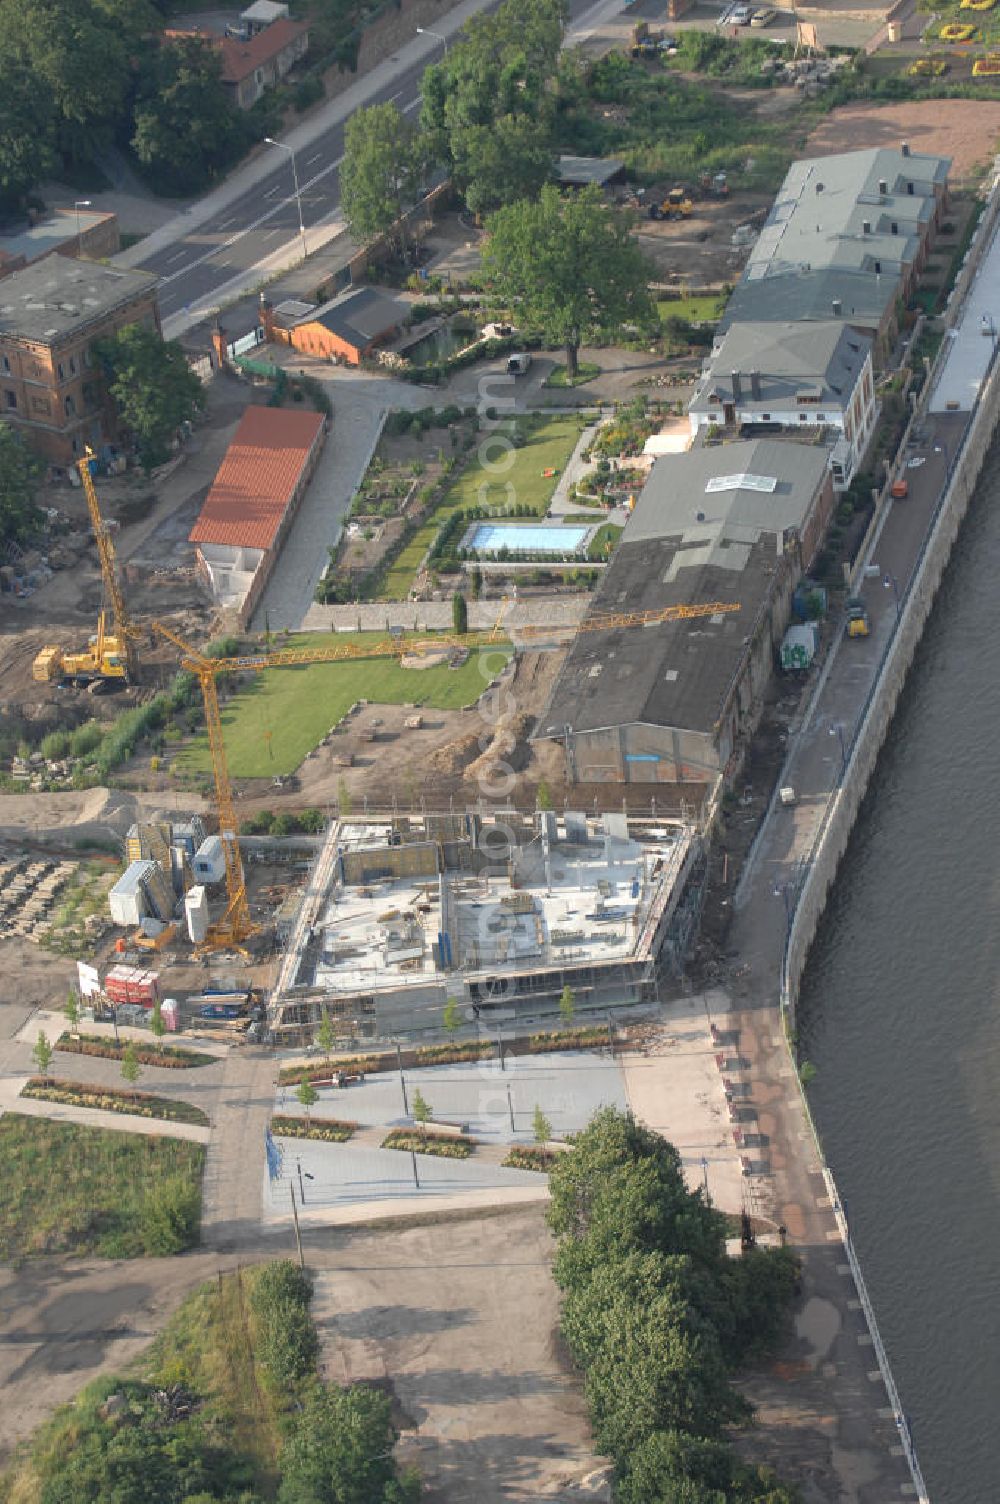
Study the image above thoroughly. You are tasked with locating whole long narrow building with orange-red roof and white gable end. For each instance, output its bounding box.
[188,408,326,626]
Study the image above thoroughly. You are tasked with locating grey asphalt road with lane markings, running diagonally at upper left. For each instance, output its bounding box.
[132,0,616,319]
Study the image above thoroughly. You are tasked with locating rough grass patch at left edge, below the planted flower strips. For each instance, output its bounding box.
[0,1113,205,1262]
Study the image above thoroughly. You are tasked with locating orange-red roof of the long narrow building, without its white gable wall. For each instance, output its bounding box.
[188,408,323,549]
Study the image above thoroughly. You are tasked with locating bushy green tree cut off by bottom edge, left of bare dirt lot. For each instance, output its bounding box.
[278,1384,420,1504]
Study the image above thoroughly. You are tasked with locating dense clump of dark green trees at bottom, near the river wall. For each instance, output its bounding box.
[549,1108,795,1504]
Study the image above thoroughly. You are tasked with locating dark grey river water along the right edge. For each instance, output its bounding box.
[800,430,1000,1504]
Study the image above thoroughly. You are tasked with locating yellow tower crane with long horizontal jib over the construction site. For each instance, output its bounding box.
[153,600,740,951]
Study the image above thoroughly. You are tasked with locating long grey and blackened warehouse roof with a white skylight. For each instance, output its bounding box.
[535,439,827,737]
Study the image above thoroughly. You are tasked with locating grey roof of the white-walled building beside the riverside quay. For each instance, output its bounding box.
[689,319,871,414]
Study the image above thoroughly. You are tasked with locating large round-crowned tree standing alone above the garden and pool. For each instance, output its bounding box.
[483,185,651,379]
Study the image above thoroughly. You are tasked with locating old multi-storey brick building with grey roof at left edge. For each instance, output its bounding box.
[0,256,159,468]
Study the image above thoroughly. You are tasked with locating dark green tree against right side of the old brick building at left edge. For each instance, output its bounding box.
[93,323,205,471]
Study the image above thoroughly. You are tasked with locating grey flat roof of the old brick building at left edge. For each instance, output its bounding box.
[0,256,158,344]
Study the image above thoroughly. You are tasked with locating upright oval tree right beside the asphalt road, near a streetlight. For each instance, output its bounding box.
[340,101,424,256]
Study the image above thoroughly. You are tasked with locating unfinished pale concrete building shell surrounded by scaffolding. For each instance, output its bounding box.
[264,811,704,1044]
